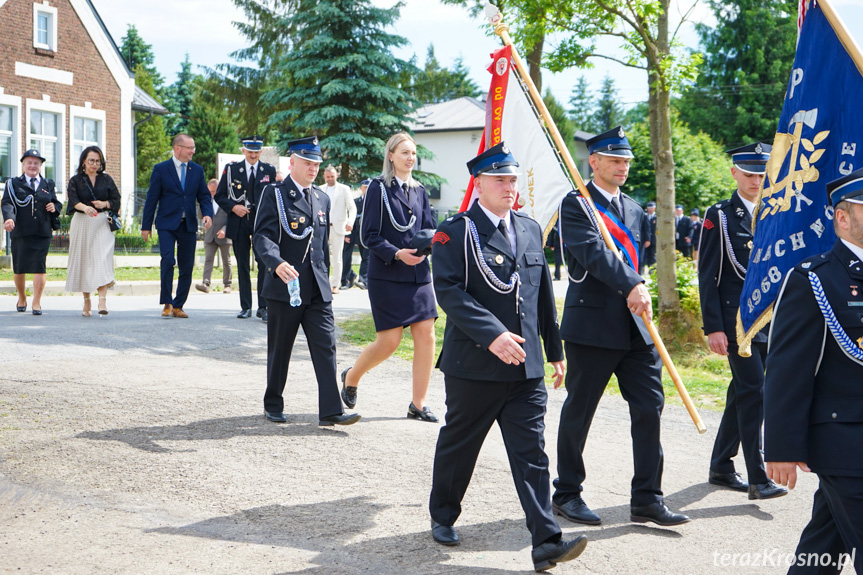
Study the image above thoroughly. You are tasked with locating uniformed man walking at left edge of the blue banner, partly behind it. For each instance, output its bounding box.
[698,143,787,499]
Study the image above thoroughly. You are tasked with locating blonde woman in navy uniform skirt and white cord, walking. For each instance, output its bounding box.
[342,132,438,423]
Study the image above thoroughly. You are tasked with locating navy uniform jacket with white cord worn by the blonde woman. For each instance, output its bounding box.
[362,177,437,283]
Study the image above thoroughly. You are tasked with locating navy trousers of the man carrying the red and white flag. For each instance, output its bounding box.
[554,320,665,506]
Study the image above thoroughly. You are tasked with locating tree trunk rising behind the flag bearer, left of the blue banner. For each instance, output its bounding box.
[647,0,680,323]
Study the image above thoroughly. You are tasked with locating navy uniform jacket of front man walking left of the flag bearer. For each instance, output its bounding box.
[432,203,563,381]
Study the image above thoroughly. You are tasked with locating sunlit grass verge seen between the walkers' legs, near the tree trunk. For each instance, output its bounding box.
[339,300,731,411]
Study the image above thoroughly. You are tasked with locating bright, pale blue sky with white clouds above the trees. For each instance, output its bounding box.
[91,0,863,111]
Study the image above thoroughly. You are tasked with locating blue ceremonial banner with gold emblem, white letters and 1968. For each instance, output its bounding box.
[737,0,863,355]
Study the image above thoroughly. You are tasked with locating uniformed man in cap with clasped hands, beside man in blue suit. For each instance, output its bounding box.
[214,136,276,321]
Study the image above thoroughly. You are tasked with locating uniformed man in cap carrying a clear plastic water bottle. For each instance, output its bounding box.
[254,136,360,426]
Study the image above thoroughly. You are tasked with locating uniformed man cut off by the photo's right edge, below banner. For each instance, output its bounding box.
[764,169,863,574]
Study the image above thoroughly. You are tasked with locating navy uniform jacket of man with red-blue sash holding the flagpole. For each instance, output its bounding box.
[560,182,653,349]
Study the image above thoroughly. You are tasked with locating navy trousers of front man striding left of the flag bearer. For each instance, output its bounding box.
[429,375,560,547]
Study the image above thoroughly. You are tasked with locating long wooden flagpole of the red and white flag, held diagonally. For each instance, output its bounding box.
[486,4,707,433]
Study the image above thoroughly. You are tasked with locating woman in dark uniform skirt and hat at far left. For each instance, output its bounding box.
[0,150,63,315]
